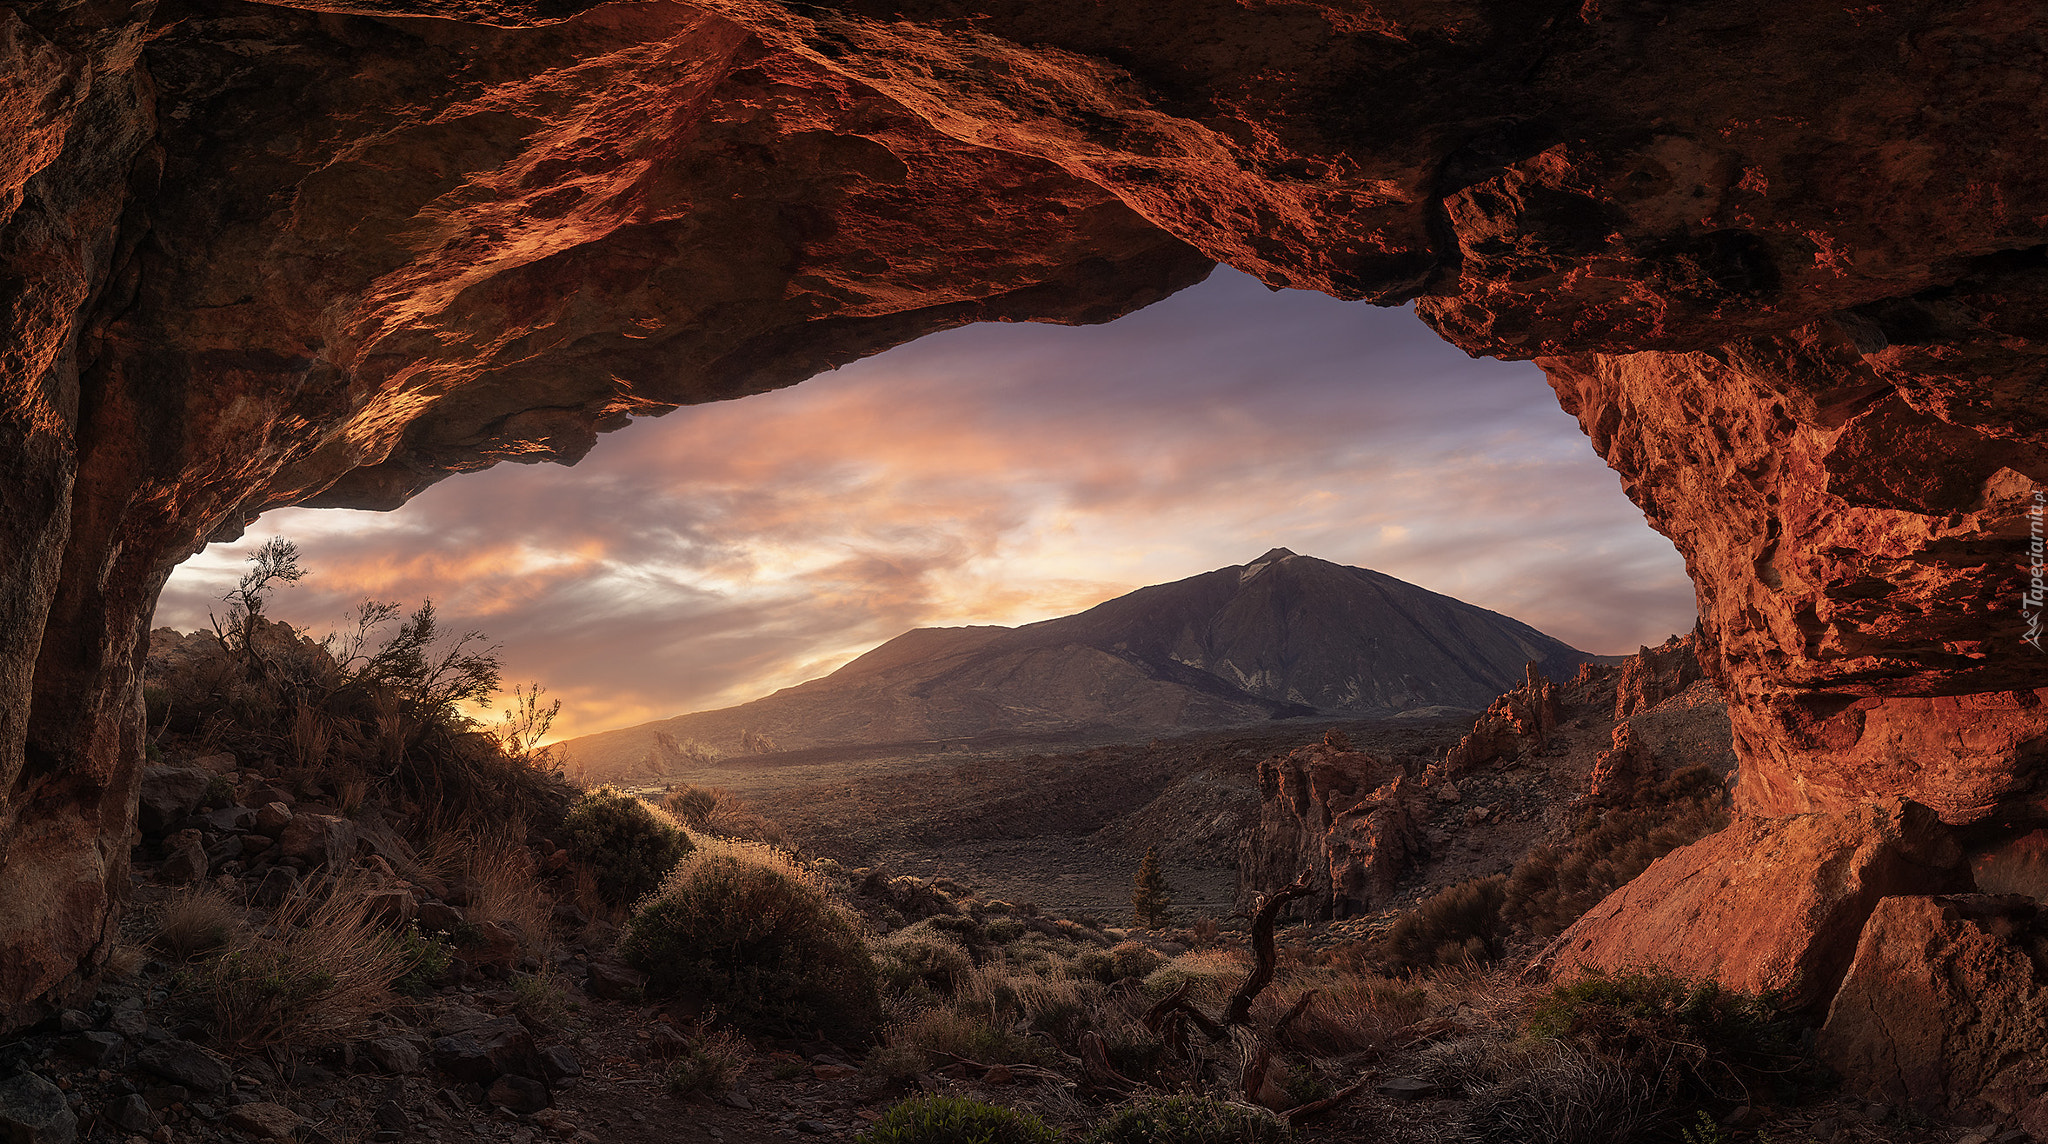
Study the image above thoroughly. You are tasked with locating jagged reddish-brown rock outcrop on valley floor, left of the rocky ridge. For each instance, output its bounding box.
[1237,741,1423,919]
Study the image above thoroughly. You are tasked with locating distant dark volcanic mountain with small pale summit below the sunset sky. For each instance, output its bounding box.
[565,548,1595,778]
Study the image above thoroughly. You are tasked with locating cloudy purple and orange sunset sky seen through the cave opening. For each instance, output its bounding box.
[156,268,1694,739]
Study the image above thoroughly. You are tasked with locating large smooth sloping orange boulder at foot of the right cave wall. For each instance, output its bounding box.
[1536,800,1968,1009]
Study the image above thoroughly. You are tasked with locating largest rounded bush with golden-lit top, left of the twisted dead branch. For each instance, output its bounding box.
[621,847,881,1040]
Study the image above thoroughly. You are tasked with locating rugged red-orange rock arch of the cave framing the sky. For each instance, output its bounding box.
[0,0,2048,1025]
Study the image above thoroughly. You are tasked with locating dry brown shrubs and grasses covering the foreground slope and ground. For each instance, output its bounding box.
[51,553,1913,1144]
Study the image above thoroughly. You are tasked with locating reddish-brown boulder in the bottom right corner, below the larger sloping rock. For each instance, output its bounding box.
[1815,894,2048,1115]
